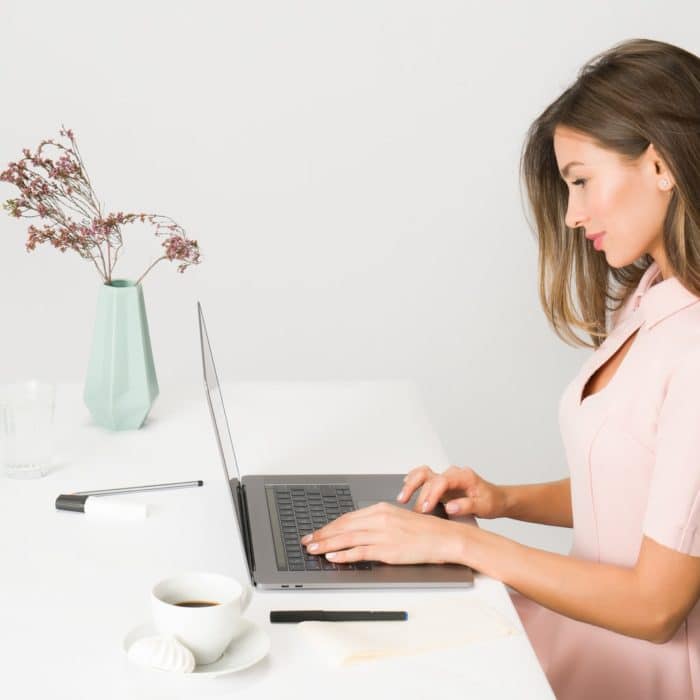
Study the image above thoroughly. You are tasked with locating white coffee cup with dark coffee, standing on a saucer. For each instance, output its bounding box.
[151,573,252,665]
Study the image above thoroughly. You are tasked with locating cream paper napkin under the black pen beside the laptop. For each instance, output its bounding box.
[297,593,520,666]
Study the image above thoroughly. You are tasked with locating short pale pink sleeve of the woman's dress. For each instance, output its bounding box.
[644,347,700,557]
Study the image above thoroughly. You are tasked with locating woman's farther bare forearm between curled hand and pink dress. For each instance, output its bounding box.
[500,478,574,527]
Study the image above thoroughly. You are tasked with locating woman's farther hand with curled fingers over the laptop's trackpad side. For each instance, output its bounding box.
[396,466,506,518]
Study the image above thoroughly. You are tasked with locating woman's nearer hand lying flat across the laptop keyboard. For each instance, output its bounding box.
[301,503,475,564]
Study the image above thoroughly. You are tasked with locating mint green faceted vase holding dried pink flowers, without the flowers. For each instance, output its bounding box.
[83,280,158,430]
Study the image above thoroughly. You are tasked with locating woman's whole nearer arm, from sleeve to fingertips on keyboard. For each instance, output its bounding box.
[302,503,700,644]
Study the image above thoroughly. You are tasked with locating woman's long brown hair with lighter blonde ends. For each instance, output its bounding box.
[520,39,700,348]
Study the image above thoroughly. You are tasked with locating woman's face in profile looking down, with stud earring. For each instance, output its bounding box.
[554,126,674,278]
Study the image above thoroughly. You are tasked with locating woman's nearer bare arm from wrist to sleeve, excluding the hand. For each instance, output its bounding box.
[459,526,700,644]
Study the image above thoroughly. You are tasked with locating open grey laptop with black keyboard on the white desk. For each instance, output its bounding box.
[197,303,474,589]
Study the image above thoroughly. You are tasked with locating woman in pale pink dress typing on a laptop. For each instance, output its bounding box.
[304,39,700,700]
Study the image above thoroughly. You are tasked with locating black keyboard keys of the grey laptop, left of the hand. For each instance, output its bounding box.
[274,484,372,571]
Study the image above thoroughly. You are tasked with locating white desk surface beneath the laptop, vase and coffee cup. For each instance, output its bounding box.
[0,382,554,700]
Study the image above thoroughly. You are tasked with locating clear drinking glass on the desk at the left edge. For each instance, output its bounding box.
[0,379,56,479]
